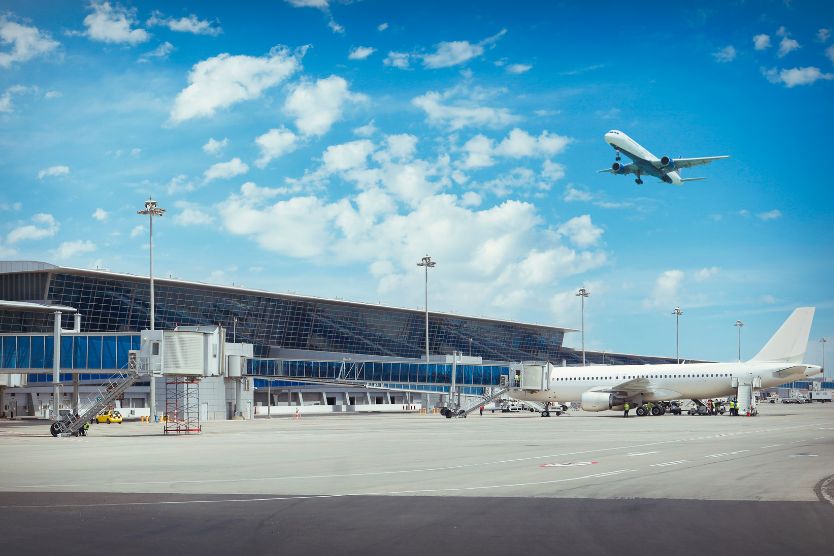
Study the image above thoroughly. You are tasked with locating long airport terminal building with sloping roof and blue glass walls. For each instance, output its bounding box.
[0,261,684,415]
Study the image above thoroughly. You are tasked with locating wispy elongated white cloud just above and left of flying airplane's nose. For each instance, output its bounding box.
[411,87,520,131]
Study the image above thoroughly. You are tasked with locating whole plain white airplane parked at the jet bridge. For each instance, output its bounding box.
[510,307,822,415]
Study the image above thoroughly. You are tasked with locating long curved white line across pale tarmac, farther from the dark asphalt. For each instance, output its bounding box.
[9,425,820,489]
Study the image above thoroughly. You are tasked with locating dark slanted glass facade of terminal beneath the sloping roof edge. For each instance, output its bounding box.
[0,262,670,367]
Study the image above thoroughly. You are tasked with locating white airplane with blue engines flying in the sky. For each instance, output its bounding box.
[600,129,730,185]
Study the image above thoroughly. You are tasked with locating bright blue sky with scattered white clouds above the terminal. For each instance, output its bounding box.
[0,0,834,370]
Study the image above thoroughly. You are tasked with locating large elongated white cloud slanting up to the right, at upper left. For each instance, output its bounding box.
[171,47,305,123]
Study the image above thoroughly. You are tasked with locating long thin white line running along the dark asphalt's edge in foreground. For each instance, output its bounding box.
[0,469,637,509]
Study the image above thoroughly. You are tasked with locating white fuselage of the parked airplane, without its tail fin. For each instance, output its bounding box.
[512,362,819,403]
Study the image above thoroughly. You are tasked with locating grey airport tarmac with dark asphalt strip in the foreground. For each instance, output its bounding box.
[0,404,834,555]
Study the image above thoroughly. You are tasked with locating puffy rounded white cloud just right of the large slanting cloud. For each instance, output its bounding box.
[284,75,367,135]
